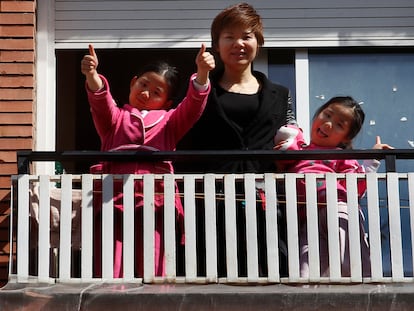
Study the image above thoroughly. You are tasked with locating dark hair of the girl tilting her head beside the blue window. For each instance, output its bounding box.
[312,96,365,149]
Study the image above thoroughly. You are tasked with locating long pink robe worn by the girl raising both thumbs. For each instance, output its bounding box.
[86,75,210,277]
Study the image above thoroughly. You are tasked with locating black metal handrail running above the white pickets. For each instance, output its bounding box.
[17,149,414,174]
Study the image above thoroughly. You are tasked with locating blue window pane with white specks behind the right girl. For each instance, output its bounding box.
[309,49,414,275]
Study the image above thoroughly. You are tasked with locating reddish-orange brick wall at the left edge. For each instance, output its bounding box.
[0,0,36,286]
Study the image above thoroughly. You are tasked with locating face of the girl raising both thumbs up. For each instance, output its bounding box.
[129,72,172,110]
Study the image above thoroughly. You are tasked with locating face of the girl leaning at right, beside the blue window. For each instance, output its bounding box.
[311,103,354,147]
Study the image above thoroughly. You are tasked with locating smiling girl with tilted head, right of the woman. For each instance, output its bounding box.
[274,96,392,277]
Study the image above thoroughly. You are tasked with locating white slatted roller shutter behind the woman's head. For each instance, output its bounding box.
[53,0,414,48]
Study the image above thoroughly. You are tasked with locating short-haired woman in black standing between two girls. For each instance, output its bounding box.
[176,3,295,275]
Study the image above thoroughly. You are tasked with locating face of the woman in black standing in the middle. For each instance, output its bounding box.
[217,27,258,66]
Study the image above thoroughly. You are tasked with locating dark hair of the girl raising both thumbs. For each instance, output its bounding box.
[137,61,180,100]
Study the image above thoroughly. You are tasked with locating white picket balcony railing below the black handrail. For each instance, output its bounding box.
[10,173,414,284]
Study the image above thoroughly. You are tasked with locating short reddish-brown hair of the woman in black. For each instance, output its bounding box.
[211,2,264,50]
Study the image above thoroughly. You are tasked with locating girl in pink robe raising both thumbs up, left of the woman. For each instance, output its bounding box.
[81,44,215,277]
